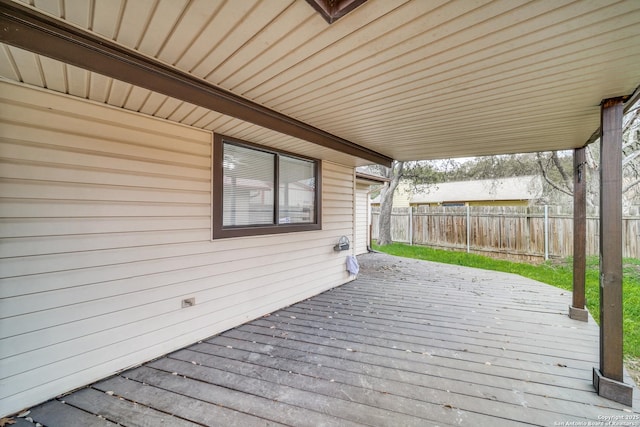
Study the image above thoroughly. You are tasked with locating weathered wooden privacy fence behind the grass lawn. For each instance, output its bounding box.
[372,206,640,260]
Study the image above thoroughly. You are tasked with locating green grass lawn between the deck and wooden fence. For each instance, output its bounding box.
[374,243,640,359]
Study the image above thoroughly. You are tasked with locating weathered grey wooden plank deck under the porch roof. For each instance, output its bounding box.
[12,254,640,427]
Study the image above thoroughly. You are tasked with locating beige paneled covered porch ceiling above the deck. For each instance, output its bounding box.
[0,0,640,166]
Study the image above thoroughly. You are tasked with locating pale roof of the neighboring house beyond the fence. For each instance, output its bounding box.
[409,176,542,204]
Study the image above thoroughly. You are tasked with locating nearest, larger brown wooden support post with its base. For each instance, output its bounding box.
[593,98,633,406]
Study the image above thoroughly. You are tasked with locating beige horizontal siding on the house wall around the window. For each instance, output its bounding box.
[0,82,354,415]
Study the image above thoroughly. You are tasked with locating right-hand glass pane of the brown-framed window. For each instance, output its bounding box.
[278,155,316,224]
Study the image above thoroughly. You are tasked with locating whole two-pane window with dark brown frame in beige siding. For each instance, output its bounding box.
[213,135,321,239]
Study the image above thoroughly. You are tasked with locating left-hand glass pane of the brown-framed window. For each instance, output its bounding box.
[222,144,275,227]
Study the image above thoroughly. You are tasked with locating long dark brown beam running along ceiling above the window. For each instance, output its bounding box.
[0,0,392,166]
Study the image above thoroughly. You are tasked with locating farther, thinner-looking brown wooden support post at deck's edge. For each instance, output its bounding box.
[569,147,589,322]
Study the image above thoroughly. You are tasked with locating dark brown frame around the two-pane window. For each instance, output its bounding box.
[211,134,322,239]
